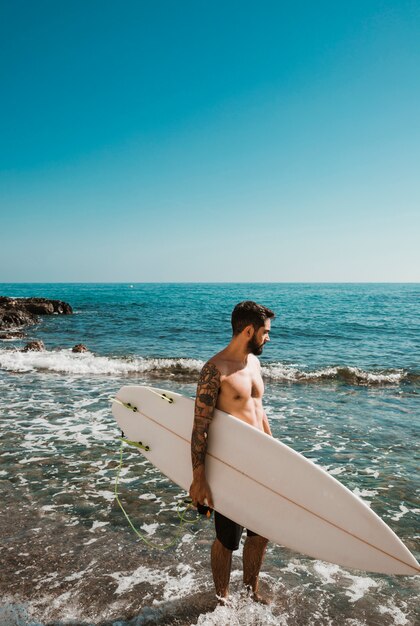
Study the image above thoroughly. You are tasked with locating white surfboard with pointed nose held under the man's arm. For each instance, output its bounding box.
[112,385,420,575]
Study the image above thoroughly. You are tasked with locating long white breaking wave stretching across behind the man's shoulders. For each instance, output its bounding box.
[0,349,420,386]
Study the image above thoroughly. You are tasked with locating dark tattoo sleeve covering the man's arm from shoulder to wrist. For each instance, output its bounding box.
[191,363,220,470]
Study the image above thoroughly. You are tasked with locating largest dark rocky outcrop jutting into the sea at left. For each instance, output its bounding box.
[0,296,73,331]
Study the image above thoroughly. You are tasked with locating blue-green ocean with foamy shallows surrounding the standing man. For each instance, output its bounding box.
[0,283,420,626]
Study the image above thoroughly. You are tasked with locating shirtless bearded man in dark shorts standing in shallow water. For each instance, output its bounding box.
[190,301,274,601]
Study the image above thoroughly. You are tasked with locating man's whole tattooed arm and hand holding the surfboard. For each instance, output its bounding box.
[190,362,220,508]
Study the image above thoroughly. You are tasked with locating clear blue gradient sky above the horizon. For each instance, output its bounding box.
[0,0,420,282]
